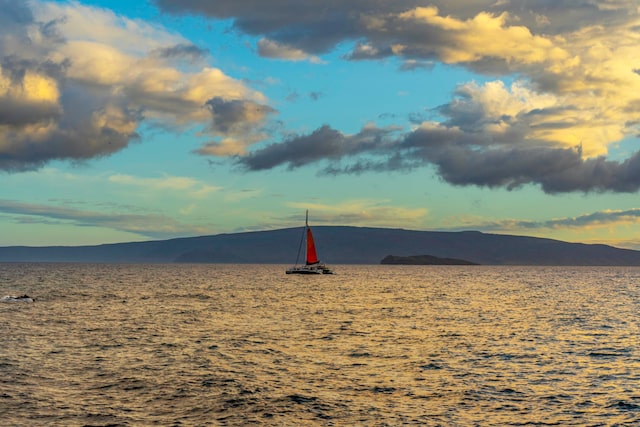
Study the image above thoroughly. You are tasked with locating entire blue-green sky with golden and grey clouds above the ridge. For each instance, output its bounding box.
[0,0,640,249]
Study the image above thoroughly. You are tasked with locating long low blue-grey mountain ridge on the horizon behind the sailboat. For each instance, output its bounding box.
[0,226,640,266]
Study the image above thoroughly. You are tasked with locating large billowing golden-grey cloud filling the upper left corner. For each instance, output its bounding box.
[0,1,266,171]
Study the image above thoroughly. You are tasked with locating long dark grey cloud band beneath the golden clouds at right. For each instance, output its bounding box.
[238,116,640,194]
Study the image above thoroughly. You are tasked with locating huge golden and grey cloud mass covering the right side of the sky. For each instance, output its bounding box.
[151,0,640,193]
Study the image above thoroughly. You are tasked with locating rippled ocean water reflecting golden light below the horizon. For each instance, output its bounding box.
[0,264,640,426]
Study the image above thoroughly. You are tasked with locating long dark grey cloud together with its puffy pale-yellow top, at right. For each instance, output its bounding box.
[232,77,640,193]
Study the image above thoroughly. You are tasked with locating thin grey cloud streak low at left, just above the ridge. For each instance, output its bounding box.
[0,199,207,239]
